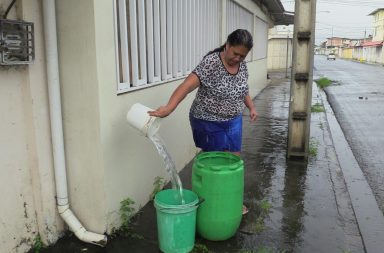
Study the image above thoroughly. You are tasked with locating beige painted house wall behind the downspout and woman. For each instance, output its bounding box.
[0,0,267,252]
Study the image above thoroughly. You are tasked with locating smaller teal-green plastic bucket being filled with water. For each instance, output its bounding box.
[154,189,199,253]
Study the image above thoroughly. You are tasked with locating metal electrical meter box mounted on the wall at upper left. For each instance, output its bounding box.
[0,19,35,65]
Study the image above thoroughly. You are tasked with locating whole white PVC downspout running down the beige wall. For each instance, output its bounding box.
[43,0,107,246]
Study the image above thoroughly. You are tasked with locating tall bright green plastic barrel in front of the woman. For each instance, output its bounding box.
[192,152,244,241]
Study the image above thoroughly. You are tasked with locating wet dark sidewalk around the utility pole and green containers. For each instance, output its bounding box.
[41,73,365,253]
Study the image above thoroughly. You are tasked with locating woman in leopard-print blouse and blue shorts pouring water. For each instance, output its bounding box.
[149,29,257,155]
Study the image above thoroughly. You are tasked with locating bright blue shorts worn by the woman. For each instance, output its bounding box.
[189,115,243,152]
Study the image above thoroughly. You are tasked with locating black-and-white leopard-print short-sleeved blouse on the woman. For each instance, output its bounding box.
[190,52,249,121]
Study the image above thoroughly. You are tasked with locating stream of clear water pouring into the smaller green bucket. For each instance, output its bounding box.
[148,133,185,204]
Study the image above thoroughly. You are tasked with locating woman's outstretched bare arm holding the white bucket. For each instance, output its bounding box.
[148,73,200,118]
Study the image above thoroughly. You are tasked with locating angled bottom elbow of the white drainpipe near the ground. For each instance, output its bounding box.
[57,205,107,247]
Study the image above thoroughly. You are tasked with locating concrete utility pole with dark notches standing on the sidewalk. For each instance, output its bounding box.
[287,0,316,159]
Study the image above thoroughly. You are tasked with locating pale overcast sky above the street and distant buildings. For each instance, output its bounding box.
[281,0,384,45]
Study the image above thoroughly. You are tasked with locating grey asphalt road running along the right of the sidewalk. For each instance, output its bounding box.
[314,55,384,212]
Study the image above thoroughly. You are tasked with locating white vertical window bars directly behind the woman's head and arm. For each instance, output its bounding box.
[115,0,221,93]
